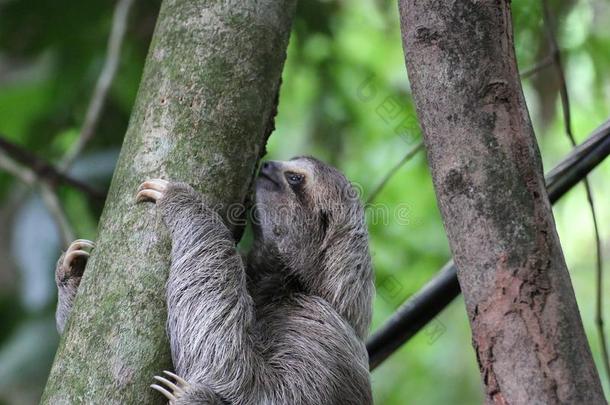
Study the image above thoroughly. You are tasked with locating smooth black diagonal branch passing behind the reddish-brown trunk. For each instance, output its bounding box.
[366,119,610,369]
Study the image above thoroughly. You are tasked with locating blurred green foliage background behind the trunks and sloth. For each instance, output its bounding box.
[0,0,610,405]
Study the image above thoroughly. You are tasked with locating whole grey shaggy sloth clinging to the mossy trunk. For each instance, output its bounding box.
[56,157,374,405]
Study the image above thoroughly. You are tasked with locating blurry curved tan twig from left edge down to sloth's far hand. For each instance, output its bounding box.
[0,151,74,248]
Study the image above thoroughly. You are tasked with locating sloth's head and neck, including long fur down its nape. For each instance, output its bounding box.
[253,157,373,338]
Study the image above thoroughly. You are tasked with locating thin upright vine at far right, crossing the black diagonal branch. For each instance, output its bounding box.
[542,0,610,381]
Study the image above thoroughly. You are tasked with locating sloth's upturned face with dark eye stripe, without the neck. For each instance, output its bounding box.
[253,157,363,268]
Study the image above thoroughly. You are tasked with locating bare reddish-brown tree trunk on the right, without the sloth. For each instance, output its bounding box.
[400,0,605,404]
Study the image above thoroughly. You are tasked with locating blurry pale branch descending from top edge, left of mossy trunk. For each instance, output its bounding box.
[59,0,134,172]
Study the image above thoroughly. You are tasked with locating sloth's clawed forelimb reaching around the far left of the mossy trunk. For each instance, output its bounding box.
[55,239,95,334]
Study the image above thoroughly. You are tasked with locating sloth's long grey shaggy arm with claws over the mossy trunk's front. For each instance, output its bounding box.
[137,179,262,404]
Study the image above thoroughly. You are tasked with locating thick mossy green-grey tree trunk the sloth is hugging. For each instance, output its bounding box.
[42,0,295,404]
